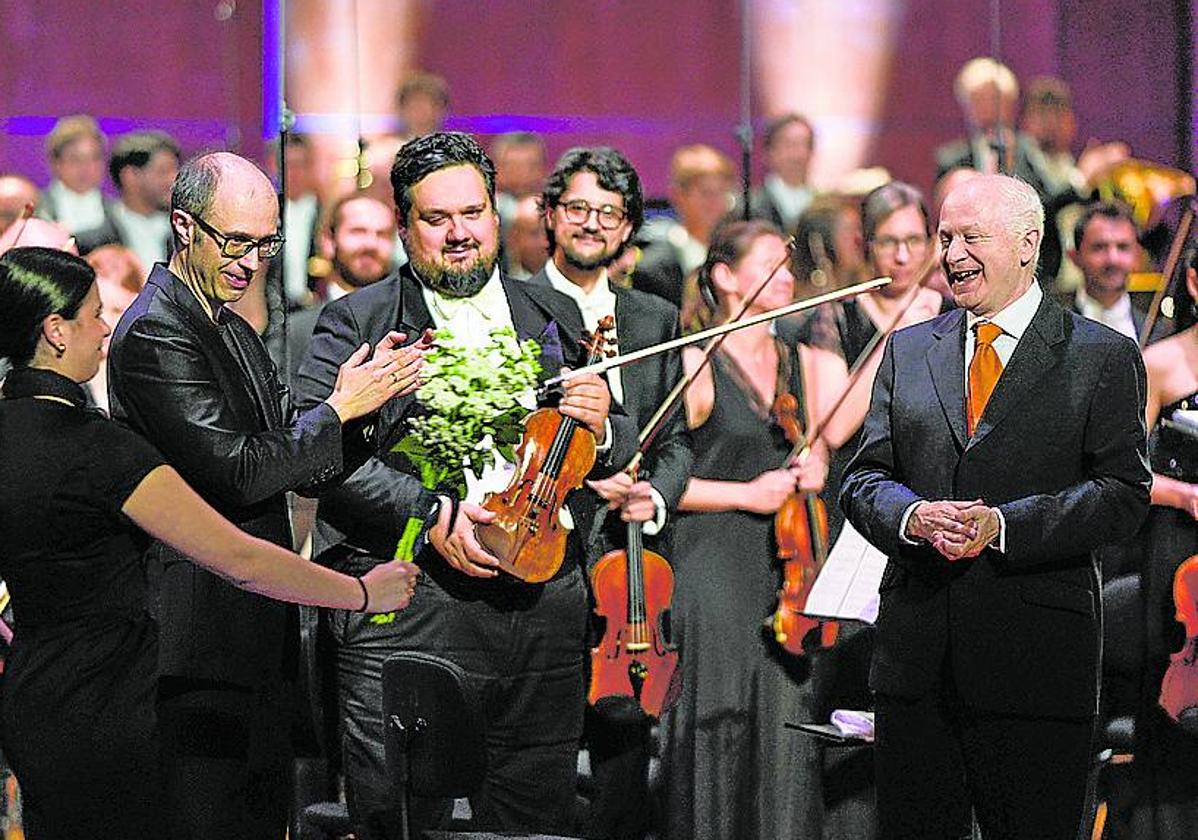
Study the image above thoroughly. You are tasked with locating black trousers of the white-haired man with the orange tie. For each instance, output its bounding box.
[875,687,1094,840]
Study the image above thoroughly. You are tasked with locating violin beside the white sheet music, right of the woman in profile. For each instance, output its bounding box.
[772,393,840,657]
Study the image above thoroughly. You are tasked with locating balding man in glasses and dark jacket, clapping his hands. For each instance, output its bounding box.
[108,152,429,840]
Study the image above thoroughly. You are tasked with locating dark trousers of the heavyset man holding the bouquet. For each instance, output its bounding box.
[331,561,587,840]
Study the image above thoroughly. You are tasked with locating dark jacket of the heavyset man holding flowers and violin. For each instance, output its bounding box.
[295,266,636,568]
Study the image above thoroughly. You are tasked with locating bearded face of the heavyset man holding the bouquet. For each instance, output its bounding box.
[399,164,500,297]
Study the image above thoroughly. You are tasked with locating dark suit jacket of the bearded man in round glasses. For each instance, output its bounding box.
[526,268,694,560]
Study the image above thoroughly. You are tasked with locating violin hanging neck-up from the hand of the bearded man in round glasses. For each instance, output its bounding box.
[587,469,678,718]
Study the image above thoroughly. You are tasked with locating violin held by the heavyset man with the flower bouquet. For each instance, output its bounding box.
[476,316,616,584]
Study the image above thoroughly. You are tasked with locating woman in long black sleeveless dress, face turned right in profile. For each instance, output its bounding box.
[662,222,846,840]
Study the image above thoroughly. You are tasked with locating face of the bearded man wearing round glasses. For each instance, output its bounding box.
[547,171,633,271]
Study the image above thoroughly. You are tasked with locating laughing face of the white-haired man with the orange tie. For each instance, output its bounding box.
[938,176,1040,318]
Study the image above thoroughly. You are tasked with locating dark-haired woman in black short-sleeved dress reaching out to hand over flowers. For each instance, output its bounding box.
[0,248,418,840]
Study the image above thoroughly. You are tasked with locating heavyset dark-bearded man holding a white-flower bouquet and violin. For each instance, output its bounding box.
[296,132,636,839]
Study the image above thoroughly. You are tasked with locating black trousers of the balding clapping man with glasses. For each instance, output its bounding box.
[158,677,292,840]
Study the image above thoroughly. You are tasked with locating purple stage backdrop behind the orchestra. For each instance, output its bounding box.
[0,0,1198,195]
